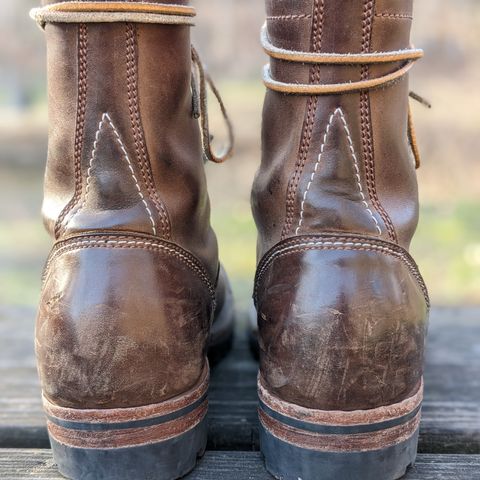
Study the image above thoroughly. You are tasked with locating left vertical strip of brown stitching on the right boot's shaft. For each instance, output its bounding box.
[281,0,325,239]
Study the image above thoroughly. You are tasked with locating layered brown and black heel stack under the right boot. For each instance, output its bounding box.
[259,379,423,480]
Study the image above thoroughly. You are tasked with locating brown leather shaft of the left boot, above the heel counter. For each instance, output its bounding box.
[43,2,217,277]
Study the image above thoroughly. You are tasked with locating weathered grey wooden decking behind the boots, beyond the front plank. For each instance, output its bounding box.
[0,308,480,454]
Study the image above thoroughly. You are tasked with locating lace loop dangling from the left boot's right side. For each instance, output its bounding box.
[192,46,234,163]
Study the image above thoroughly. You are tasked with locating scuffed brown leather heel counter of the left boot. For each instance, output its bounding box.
[36,235,214,408]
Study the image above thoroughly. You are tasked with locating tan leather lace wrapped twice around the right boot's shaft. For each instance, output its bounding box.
[260,24,431,168]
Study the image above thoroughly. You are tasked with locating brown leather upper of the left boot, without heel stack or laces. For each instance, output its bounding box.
[36,1,232,408]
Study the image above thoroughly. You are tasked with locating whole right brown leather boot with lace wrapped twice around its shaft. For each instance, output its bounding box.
[252,0,429,480]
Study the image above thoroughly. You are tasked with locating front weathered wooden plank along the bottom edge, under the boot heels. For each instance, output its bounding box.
[0,449,480,480]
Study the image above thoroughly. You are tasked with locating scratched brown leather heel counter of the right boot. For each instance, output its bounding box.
[257,239,428,411]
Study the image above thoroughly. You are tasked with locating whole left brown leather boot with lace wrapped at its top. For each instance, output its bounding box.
[33,0,233,480]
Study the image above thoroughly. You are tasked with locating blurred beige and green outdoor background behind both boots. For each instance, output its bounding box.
[0,0,480,316]
